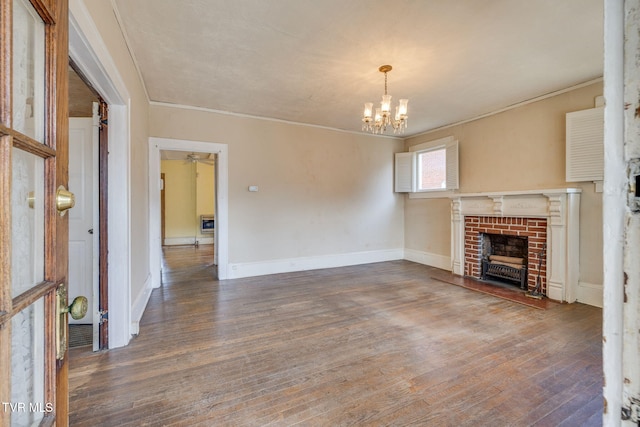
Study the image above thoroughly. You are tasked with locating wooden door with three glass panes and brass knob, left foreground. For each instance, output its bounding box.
[0,0,73,426]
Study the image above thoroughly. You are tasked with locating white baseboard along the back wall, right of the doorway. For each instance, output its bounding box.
[227,249,404,279]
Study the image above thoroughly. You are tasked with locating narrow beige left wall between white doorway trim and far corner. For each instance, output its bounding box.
[82,0,150,304]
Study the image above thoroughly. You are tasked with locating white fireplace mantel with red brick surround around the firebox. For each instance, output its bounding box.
[451,188,581,302]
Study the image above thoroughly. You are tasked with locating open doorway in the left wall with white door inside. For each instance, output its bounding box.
[69,61,108,351]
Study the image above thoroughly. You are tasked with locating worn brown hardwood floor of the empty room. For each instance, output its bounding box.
[69,246,603,426]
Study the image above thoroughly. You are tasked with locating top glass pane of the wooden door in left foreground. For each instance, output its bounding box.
[11,0,45,142]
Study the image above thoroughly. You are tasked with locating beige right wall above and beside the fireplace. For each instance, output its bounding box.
[405,83,602,290]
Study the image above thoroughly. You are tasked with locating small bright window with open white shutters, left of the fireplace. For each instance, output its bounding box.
[395,137,459,193]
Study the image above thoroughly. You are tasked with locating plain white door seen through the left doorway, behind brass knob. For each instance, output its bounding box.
[69,113,98,328]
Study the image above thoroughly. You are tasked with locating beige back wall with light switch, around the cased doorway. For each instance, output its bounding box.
[150,105,404,263]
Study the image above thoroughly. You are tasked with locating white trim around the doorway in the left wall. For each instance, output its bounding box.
[69,0,135,348]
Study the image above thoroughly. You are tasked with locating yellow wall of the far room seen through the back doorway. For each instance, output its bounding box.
[160,160,215,244]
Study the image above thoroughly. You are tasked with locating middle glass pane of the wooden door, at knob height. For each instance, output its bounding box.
[11,147,44,298]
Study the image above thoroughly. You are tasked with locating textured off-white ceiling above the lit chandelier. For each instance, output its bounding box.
[115,0,603,135]
